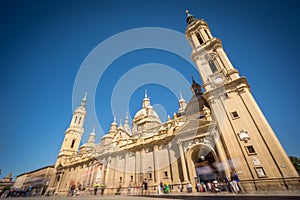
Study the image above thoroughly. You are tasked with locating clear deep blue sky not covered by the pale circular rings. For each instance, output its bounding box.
[0,0,300,178]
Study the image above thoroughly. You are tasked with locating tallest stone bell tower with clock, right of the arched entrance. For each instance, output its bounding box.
[185,11,298,190]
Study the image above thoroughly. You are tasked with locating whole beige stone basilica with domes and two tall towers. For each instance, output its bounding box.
[47,12,300,195]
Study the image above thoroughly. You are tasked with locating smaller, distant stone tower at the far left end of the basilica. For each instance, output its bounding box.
[55,93,87,167]
